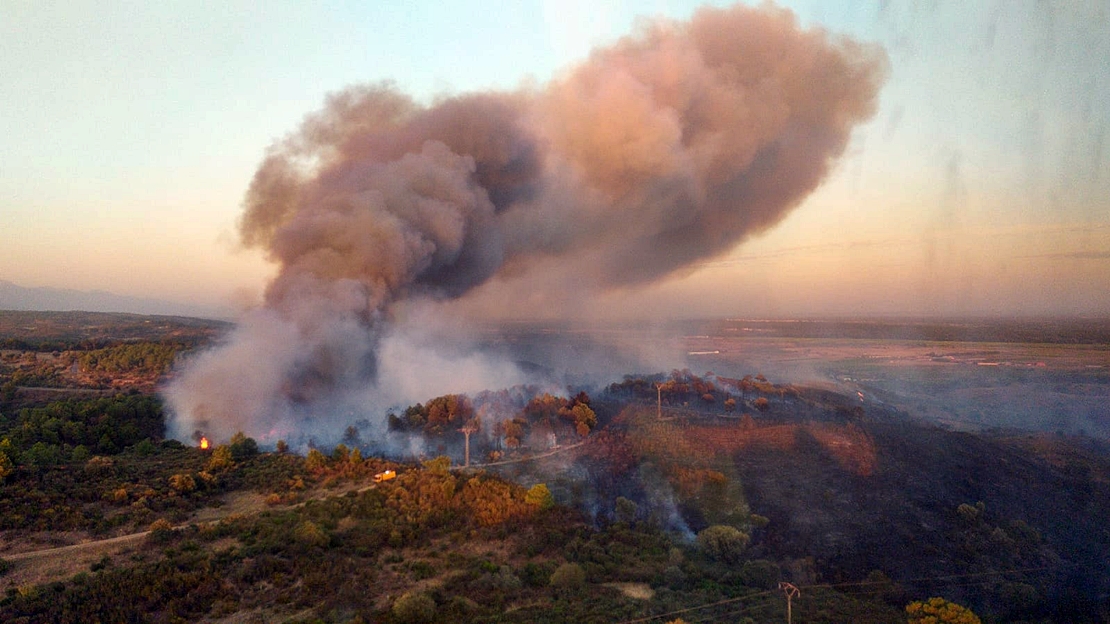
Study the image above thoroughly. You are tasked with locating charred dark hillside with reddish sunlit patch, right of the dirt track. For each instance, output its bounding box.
[490,373,1110,622]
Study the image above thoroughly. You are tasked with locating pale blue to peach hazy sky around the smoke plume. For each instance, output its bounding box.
[0,0,1110,316]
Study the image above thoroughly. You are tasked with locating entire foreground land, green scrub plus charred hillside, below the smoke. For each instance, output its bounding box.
[0,317,1110,622]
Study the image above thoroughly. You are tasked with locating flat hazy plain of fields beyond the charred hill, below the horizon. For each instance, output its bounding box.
[491,320,1110,440]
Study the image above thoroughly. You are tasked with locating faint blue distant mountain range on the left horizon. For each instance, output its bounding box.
[0,280,234,319]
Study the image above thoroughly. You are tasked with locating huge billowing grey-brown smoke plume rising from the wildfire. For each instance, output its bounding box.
[168,6,885,439]
